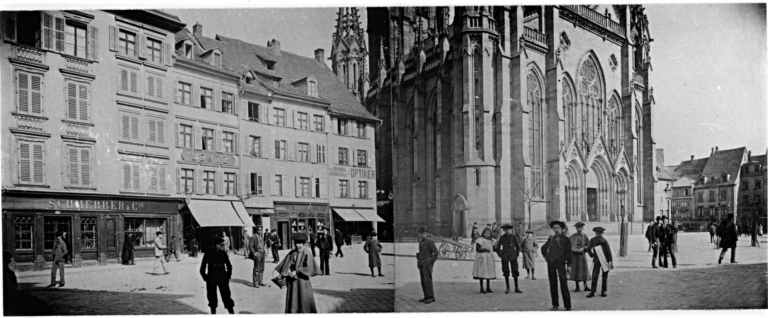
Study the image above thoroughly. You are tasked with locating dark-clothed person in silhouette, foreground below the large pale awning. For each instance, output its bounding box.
[200,238,235,314]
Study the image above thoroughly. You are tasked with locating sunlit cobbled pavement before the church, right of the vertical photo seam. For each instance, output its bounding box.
[395,233,768,312]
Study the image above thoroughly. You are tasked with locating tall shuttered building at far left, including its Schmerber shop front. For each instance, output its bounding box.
[0,10,184,269]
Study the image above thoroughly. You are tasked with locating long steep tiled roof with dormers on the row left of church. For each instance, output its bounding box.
[176,29,378,120]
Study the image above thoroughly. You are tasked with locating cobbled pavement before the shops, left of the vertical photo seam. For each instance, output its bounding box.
[17,243,395,315]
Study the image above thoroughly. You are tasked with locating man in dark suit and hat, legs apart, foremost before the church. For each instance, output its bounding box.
[541,221,573,310]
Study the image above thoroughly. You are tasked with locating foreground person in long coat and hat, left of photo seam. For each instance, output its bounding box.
[275,233,319,313]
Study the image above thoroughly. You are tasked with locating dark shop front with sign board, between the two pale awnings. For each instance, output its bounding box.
[269,202,333,249]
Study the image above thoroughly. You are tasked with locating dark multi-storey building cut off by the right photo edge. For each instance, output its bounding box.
[737,151,768,228]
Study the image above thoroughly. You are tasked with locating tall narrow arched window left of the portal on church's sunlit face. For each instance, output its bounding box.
[526,71,543,197]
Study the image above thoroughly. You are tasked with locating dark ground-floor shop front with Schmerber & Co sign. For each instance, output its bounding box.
[3,191,183,270]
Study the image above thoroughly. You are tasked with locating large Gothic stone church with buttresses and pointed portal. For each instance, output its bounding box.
[366,5,658,236]
